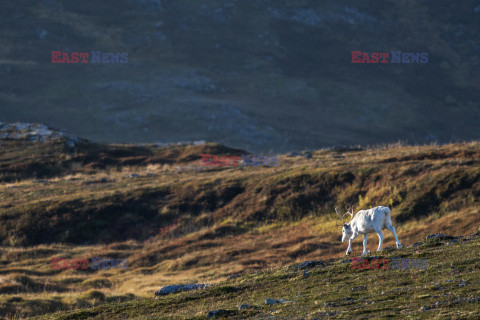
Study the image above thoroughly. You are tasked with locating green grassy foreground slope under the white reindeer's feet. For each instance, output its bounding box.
[30,233,480,320]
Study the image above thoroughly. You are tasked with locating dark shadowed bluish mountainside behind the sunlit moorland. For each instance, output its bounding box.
[0,0,480,152]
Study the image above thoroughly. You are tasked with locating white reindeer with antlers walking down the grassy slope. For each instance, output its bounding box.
[335,207,402,256]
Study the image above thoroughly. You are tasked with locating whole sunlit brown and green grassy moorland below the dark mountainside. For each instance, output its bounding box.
[0,140,480,319]
